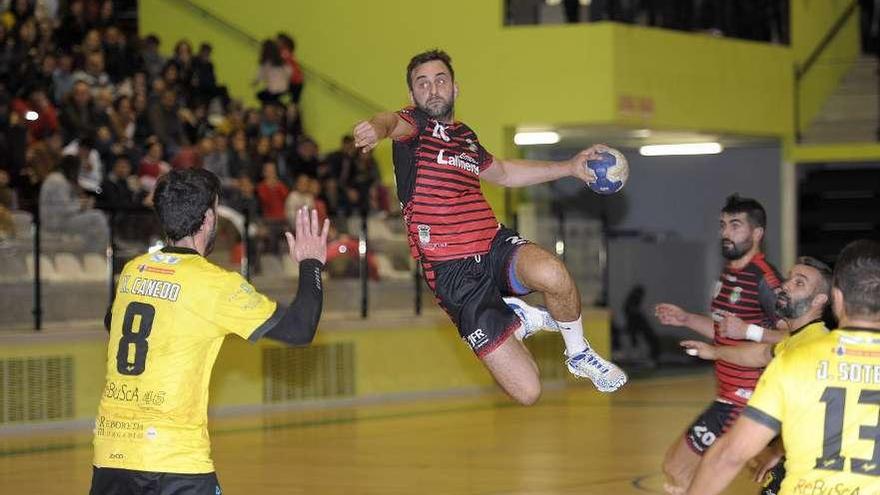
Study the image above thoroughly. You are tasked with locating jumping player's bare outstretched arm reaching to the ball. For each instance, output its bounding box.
[480,144,608,187]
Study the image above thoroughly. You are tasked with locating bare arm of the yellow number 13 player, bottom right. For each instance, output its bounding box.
[686,416,777,495]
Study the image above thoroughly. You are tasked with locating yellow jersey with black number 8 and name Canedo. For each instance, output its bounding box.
[94,247,281,474]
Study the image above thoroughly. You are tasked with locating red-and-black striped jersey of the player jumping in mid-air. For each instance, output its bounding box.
[393,107,498,261]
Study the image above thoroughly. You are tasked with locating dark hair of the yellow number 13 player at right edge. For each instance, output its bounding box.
[834,240,880,321]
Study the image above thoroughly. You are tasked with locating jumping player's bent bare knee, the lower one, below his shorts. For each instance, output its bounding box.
[481,335,541,406]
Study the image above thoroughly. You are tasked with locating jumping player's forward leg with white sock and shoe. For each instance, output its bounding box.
[515,244,627,392]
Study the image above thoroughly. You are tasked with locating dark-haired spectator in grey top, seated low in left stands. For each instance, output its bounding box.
[40,155,108,252]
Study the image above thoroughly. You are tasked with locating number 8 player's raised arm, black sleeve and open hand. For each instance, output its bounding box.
[265,208,330,345]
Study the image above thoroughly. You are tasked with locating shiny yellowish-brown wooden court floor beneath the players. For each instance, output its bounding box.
[0,371,758,495]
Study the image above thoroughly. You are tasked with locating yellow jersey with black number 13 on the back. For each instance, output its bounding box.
[743,329,880,495]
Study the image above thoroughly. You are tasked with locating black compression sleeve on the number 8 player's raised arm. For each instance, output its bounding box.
[264,258,324,345]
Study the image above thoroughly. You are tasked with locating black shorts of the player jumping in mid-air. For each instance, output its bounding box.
[422,226,531,358]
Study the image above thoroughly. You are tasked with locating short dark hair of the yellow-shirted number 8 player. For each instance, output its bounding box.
[153,168,220,241]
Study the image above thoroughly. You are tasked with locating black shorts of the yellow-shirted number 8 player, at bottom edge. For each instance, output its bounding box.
[89,466,223,495]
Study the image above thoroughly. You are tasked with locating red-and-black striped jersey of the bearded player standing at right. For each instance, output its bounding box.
[712,253,782,406]
